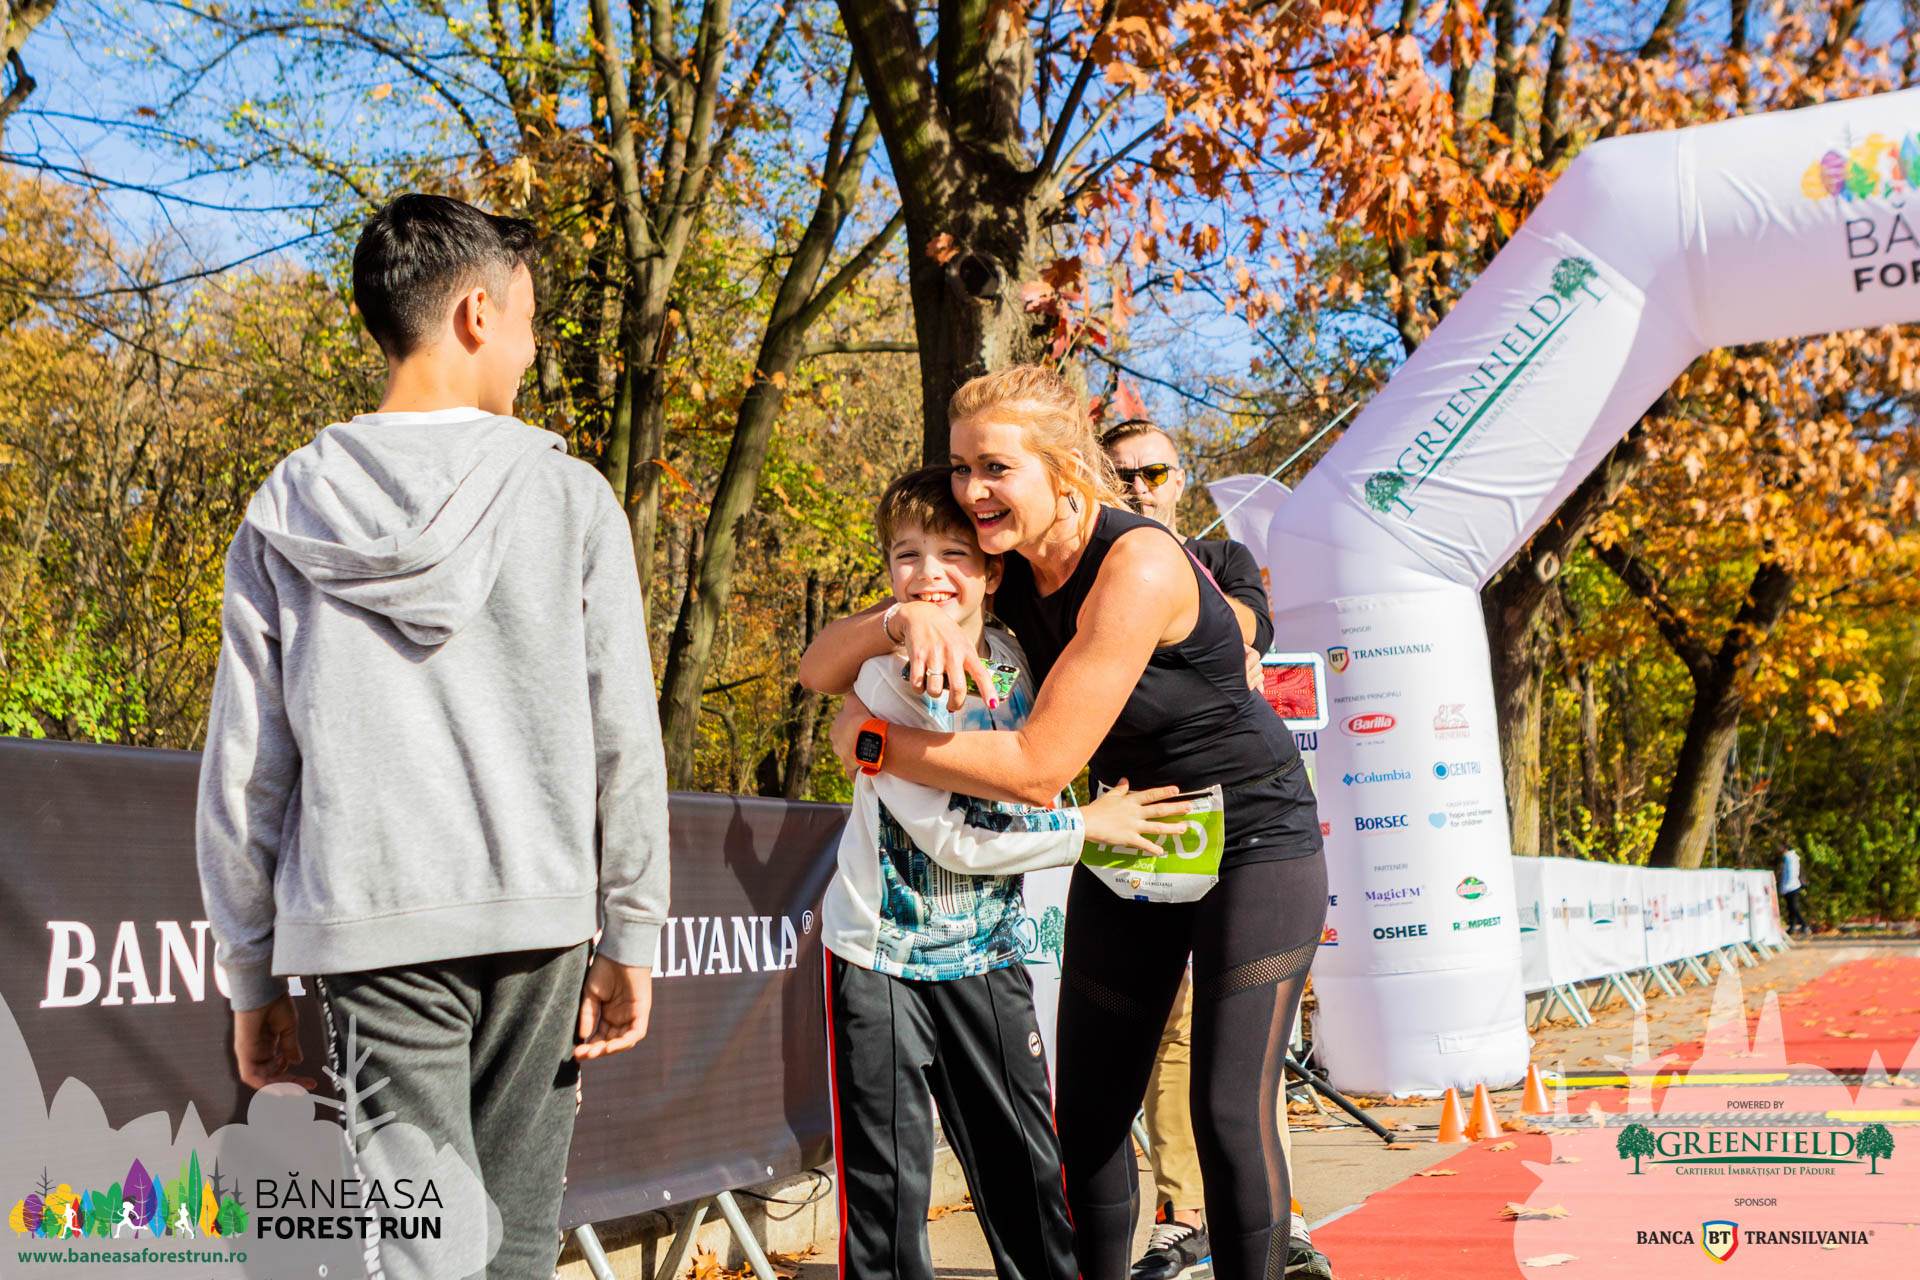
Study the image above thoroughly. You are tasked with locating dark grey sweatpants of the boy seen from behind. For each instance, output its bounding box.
[319,942,588,1280]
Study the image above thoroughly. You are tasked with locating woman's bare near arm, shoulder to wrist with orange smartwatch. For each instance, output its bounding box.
[833,530,1200,804]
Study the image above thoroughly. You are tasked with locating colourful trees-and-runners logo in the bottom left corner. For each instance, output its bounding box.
[8,1151,248,1261]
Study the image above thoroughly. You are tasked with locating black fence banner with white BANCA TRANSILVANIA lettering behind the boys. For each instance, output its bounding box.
[0,739,847,1226]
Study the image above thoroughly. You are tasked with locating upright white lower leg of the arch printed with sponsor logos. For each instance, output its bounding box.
[1277,589,1526,1092]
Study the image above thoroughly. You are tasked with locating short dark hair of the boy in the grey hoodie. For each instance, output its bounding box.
[353,192,540,361]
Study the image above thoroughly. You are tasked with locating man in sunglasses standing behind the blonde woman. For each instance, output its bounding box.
[1100,418,1332,1280]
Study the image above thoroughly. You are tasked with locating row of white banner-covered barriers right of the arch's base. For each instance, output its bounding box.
[1513,858,1786,1025]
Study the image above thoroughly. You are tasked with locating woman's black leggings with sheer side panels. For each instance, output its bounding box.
[1056,852,1327,1280]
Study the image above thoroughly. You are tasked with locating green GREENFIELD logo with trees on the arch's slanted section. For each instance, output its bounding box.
[1361,257,1607,520]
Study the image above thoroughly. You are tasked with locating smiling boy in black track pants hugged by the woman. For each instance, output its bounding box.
[824,466,1175,1280]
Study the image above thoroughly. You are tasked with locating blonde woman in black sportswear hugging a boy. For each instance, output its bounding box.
[801,367,1327,1280]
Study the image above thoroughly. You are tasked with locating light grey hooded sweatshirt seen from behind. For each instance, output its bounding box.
[198,409,666,1009]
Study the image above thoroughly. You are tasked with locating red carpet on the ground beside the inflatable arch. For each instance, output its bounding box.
[1313,958,1920,1280]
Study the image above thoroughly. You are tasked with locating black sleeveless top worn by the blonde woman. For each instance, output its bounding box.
[993,507,1321,865]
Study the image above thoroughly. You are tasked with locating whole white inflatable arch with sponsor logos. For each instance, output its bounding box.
[1254,90,1920,1092]
